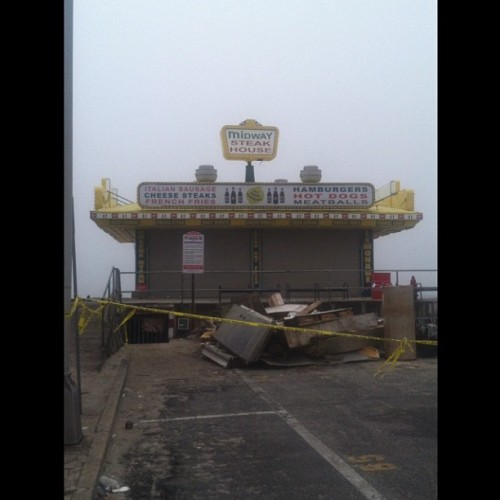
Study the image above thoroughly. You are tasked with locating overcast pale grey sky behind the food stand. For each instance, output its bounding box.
[73,0,437,296]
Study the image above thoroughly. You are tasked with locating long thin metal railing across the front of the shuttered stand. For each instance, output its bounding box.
[103,267,438,303]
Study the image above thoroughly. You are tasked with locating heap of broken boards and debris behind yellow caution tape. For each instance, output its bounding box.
[200,293,384,368]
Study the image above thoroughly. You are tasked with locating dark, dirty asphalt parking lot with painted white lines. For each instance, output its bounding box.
[93,338,438,500]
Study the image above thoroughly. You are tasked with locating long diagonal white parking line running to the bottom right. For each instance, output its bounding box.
[235,369,384,500]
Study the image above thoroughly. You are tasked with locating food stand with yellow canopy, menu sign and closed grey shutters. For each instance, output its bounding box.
[90,172,422,300]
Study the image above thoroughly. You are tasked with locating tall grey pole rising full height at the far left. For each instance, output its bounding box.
[64,0,83,445]
